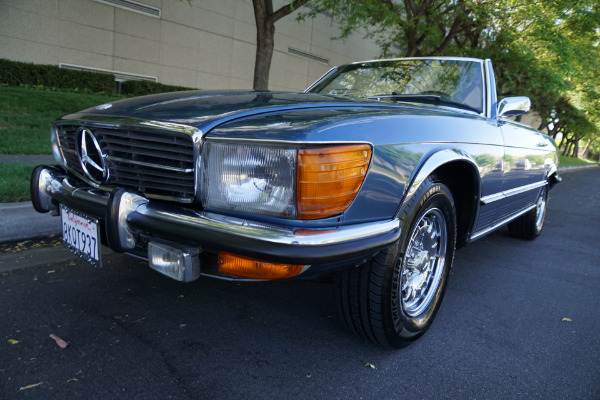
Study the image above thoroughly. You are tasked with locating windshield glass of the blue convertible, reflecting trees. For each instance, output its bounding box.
[310,59,483,112]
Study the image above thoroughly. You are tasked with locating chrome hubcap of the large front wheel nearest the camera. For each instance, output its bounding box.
[400,208,448,317]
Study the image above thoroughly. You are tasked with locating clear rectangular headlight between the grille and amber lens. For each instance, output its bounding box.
[200,141,297,218]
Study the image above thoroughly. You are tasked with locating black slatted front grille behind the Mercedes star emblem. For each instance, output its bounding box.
[58,125,195,202]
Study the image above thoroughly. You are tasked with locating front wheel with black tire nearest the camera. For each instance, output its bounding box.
[335,177,456,348]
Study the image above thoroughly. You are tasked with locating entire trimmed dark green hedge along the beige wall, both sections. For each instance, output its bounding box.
[0,59,190,97]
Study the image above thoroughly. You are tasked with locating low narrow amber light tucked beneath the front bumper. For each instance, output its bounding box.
[218,252,304,279]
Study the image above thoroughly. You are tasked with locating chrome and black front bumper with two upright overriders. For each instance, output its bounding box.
[31,165,400,282]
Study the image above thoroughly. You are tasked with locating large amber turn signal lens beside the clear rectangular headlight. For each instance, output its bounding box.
[296,144,371,220]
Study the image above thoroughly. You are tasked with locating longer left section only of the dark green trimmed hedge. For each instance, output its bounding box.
[0,59,115,94]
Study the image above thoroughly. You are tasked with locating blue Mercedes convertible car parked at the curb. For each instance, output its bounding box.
[31,57,559,347]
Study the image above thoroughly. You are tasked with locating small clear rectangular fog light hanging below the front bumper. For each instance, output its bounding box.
[148,242,200,282]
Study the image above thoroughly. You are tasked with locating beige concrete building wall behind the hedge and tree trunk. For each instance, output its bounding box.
[0,0,379,91]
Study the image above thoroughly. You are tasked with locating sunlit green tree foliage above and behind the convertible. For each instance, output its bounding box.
[306,0,600,158]
